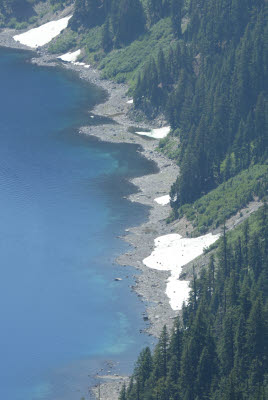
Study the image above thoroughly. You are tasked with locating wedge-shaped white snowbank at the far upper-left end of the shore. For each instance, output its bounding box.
[14,15,72,49]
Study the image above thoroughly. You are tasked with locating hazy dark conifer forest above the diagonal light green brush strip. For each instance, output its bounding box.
[128,0,268,210]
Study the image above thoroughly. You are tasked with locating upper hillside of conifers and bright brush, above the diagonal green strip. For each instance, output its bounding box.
[46,0,268,219]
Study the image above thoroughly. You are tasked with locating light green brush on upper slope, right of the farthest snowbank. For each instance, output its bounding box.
[49,18,173,85]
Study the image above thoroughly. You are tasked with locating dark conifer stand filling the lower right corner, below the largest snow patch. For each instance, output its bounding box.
[121,205,268,400]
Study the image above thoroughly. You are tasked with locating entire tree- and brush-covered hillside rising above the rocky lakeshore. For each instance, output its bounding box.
[0,0,268,400]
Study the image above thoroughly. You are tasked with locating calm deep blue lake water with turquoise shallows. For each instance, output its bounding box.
[0,49,154,400]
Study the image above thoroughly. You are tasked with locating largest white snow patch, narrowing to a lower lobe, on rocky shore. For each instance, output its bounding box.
[143,233,220,310]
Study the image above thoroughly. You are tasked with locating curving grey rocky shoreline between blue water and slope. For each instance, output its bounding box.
[0,30,179,400]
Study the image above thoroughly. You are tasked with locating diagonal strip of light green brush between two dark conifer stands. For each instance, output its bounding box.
[173,164,268,235]
